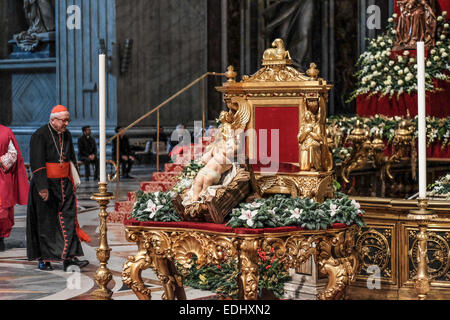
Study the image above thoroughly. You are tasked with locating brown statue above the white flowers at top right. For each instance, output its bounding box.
[396,0,437,50]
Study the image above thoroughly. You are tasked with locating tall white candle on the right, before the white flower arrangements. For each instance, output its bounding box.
[417,42,427,199]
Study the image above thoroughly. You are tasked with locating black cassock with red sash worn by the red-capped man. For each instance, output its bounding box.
[27,125,84,261]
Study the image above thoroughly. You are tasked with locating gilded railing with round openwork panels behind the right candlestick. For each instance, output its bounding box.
[349,198,450,300]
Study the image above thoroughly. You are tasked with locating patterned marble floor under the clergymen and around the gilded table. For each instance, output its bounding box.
[0,166,215,300]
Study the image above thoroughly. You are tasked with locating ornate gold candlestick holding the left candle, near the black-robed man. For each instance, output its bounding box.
[91,182,114,300]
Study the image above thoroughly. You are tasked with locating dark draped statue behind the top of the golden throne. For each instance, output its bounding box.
[263,0,314,67]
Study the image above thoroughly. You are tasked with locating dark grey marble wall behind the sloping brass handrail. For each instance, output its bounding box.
[116,0,214,127]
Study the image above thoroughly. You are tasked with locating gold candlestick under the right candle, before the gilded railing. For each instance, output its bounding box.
[408,199,438,300]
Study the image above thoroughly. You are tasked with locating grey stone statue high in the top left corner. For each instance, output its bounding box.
[23,0,55,34]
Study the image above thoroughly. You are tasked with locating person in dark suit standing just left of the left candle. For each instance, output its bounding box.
[78,126,99,181]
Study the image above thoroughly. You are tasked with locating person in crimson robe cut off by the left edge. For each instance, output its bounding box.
[0,125,28,251]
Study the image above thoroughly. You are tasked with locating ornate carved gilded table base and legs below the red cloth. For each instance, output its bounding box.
[122,226,360,300]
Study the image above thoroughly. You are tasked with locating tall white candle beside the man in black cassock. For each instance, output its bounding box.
[98,54,106,183]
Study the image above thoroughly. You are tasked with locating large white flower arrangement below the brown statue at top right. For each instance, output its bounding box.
[348,11,450,102]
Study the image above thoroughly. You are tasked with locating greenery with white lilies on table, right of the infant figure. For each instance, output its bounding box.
[227,193,365,230]
